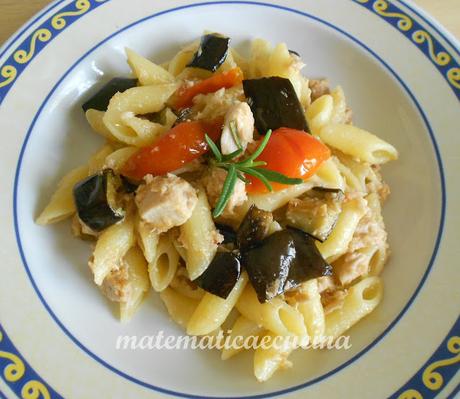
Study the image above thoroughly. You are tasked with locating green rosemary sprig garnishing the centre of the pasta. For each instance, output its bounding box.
[205,130,303,218]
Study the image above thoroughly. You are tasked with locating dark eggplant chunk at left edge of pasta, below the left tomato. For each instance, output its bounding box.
[73,169,125,231]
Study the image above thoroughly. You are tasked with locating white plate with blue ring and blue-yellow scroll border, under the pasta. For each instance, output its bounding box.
[0,0,460,398]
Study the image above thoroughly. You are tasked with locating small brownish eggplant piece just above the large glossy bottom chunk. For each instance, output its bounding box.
[236,205,273,251]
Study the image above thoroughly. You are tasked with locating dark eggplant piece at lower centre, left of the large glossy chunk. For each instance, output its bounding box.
[193,252,241,299]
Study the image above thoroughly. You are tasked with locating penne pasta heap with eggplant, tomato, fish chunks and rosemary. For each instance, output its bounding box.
[37,33,398,381]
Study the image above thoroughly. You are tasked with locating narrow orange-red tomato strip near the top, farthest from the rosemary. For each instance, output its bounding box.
[174,67,243,109]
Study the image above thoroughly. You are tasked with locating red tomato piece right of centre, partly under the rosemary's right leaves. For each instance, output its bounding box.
[246,127,331,193]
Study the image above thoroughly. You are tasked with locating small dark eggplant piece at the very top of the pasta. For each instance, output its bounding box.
[187,34,230,72]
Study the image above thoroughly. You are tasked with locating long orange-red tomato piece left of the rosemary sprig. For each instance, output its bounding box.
[122,121,222,180]
